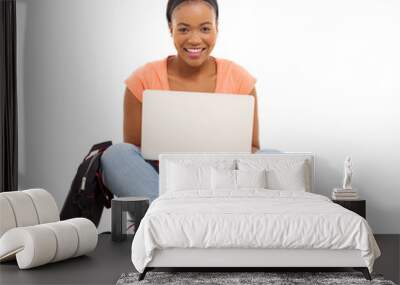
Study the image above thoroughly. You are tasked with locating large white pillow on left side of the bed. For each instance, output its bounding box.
[166,159,235,191]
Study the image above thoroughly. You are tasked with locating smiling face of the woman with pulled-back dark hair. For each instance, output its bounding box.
[169,1,218,67]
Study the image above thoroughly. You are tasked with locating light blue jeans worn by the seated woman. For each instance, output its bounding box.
[101,143,280,202]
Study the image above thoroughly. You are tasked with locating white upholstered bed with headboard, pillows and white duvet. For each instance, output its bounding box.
[132,153,380,280]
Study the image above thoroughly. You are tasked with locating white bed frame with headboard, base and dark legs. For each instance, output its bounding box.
[139,153,371,280]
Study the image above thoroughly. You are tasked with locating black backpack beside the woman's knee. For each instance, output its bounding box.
[60,141,113,226]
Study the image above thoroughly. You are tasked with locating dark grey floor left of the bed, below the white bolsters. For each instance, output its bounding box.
[0,234,135,285]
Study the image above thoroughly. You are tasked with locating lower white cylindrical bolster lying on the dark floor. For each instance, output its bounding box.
[0,218,97,269]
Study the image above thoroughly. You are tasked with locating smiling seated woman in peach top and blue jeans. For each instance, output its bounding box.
[102,0,259,199]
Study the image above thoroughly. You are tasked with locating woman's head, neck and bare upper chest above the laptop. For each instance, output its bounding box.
[167,1,218,88]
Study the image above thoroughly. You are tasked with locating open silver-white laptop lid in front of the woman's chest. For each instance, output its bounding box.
[141,90,254,160]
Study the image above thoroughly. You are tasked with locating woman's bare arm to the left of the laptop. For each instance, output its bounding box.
[124,88,142,147]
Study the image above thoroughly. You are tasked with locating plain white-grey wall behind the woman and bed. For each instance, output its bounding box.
[17,0,400,233]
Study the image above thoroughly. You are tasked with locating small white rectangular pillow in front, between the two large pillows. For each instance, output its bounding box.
[211,168,267,190]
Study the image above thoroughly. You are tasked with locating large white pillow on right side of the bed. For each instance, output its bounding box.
[237,158,311,191]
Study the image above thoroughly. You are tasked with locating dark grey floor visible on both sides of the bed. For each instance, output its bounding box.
[0,234,400,285]
